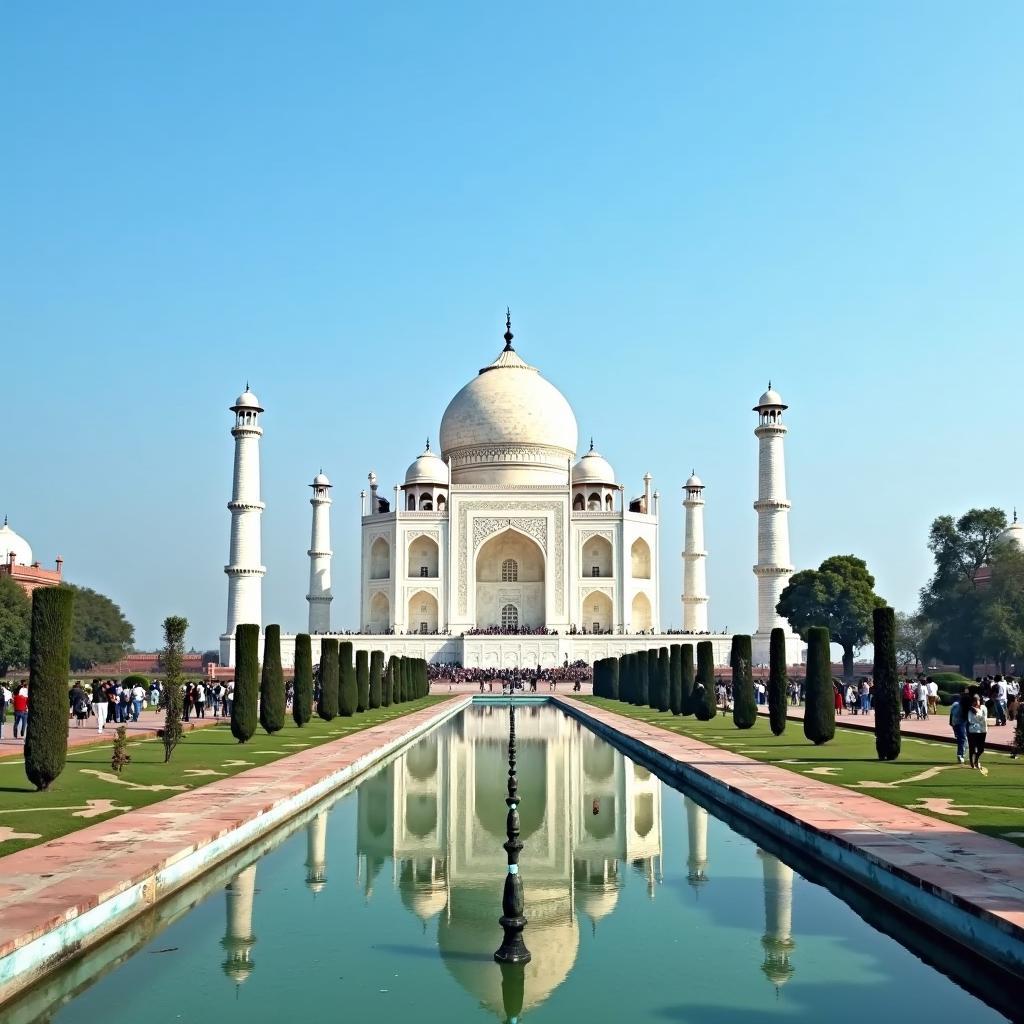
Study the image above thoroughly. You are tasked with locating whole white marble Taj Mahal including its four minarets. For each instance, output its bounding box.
[220,316,801,668]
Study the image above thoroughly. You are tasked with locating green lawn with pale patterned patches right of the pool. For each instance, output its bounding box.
[581,697,1024,846]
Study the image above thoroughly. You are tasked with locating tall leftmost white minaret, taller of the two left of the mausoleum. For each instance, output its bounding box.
[220,384,266,666]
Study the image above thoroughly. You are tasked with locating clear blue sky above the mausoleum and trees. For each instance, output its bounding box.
[0,0,1024,647]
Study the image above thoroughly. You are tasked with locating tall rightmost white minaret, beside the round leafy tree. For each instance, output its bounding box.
[754,381,793,663]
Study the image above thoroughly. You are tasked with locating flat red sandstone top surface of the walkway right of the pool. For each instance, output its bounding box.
[564,699,1024,929]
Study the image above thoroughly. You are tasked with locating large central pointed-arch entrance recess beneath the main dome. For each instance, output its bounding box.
[475,527,545,633]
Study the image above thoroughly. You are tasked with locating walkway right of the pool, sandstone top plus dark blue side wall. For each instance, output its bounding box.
[554,697,1024,975]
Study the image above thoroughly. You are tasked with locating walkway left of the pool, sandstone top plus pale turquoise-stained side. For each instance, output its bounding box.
[0,696,471,1005]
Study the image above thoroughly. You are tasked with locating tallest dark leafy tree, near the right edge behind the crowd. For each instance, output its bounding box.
[921,508,1007,676]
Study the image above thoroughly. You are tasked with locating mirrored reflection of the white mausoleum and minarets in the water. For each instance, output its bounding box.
[222,706,794,1013]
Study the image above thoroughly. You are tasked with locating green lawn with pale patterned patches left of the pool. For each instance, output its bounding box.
[0,696,444,856]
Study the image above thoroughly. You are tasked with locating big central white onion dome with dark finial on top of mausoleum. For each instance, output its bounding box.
[440,321,578,486]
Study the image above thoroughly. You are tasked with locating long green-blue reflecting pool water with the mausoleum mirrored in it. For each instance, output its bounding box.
[14,705,1004,1024]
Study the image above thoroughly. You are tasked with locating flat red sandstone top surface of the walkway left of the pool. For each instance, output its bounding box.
[0,700,464,956]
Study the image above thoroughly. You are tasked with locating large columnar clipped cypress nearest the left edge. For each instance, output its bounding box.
[24,587,75,791]
